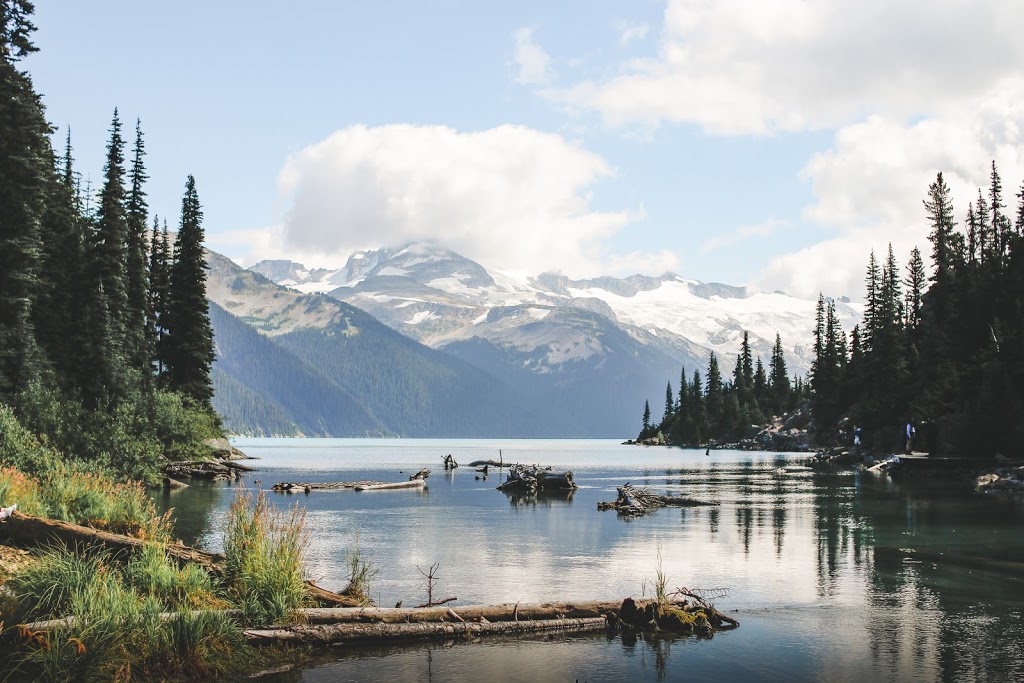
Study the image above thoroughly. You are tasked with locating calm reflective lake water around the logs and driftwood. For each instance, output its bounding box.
[151,439,1024,683]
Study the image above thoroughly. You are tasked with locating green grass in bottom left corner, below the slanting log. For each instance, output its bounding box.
[0,548,251,681]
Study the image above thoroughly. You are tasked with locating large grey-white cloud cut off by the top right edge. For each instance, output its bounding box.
[545,0,1024,134]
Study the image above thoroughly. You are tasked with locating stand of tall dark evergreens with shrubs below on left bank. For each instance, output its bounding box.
[0,0,219,475]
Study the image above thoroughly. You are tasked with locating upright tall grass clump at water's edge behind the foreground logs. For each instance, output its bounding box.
[224,490,308,625]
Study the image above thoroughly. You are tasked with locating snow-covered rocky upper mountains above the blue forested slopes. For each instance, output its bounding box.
[251,244,861,379]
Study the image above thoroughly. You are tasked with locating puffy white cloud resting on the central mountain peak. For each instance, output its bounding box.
[279,125,642,275]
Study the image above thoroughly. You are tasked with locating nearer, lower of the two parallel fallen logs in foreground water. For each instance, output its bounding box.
[245,616,607,645]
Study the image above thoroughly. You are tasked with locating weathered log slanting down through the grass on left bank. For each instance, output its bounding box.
[0,512,360,607]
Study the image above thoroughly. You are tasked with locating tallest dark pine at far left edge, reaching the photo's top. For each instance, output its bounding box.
[0,6,47,399]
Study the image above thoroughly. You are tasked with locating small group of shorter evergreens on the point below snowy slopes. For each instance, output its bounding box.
[637,332,808,446]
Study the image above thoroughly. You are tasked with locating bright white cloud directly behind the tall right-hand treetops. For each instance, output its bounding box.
[761,78,1024,298]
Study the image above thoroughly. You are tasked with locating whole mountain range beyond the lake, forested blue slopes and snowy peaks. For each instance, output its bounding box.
[208,243,860,437]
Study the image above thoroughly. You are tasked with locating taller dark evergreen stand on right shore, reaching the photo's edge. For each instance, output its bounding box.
[811,161,1024,457]
